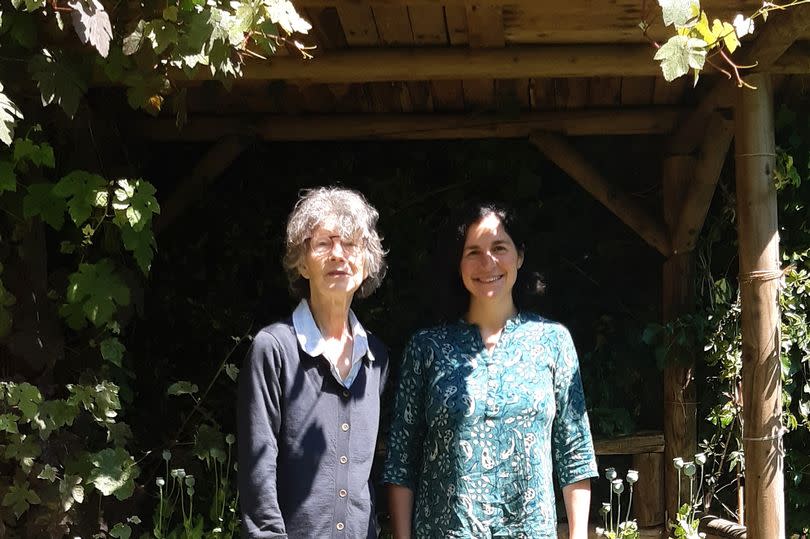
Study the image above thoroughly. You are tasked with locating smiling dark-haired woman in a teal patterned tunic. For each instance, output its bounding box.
[384,204,597,539]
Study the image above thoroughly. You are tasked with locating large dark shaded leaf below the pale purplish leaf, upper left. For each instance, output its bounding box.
[28,49,87,118]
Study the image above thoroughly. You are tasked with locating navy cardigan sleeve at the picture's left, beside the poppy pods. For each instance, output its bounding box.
[237,331,287,539]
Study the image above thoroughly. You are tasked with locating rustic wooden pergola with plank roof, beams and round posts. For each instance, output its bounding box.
[138,0,810,539]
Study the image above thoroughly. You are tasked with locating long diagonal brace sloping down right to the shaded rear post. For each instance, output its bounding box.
[529,131,672,256]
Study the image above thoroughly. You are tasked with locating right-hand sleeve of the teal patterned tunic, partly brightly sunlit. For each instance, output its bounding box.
[551,328,599,487]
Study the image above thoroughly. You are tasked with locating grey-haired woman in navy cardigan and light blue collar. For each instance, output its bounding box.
[238,188,388,539]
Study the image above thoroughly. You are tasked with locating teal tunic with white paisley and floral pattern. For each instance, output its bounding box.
[384,313,598,539]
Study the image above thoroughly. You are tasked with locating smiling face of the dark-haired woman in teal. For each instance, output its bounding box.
[459,213,523,306]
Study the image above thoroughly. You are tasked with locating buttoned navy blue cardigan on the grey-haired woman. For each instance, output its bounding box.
[237,320,388,539]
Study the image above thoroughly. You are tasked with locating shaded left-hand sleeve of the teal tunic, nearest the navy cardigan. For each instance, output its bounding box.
[383,337,426,490]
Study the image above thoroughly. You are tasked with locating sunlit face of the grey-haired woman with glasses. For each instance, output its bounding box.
[298,222,368,297]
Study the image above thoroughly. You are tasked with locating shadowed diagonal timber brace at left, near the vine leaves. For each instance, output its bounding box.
[154,136,247,234]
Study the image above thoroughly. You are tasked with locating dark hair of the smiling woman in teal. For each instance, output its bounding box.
[431,201,546,322]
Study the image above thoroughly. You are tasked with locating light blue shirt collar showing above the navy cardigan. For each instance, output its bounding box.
[293,299,374,389]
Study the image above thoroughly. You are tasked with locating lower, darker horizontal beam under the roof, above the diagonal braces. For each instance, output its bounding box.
[131,107,681,142]
